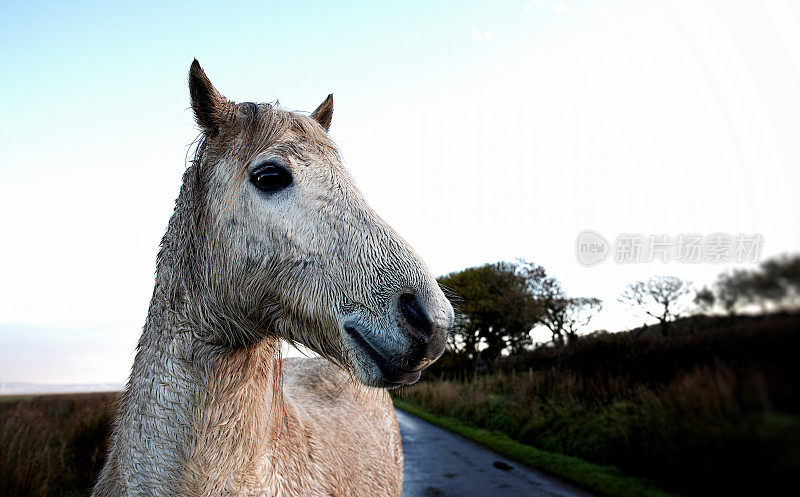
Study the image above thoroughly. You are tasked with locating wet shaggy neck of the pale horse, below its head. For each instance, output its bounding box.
[103,179,284,495]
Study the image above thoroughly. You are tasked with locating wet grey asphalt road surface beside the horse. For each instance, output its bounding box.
[396,409,590,497]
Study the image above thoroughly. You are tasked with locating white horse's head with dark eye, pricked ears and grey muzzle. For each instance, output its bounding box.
[179,60,453,387]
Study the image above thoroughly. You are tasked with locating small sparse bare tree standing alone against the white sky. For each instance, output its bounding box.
[618,276,691,336]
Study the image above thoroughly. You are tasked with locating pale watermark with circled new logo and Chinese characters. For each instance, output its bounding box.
[575,230,764,266]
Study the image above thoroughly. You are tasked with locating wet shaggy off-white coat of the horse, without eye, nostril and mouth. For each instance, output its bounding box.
[93,61,452,497]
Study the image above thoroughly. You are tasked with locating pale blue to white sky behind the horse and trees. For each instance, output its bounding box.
[0,0,800,383]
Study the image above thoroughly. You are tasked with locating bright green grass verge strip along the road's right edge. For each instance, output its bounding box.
[392,398,675,497]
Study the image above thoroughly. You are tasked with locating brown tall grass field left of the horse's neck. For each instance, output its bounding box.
[0,393,118,497]
